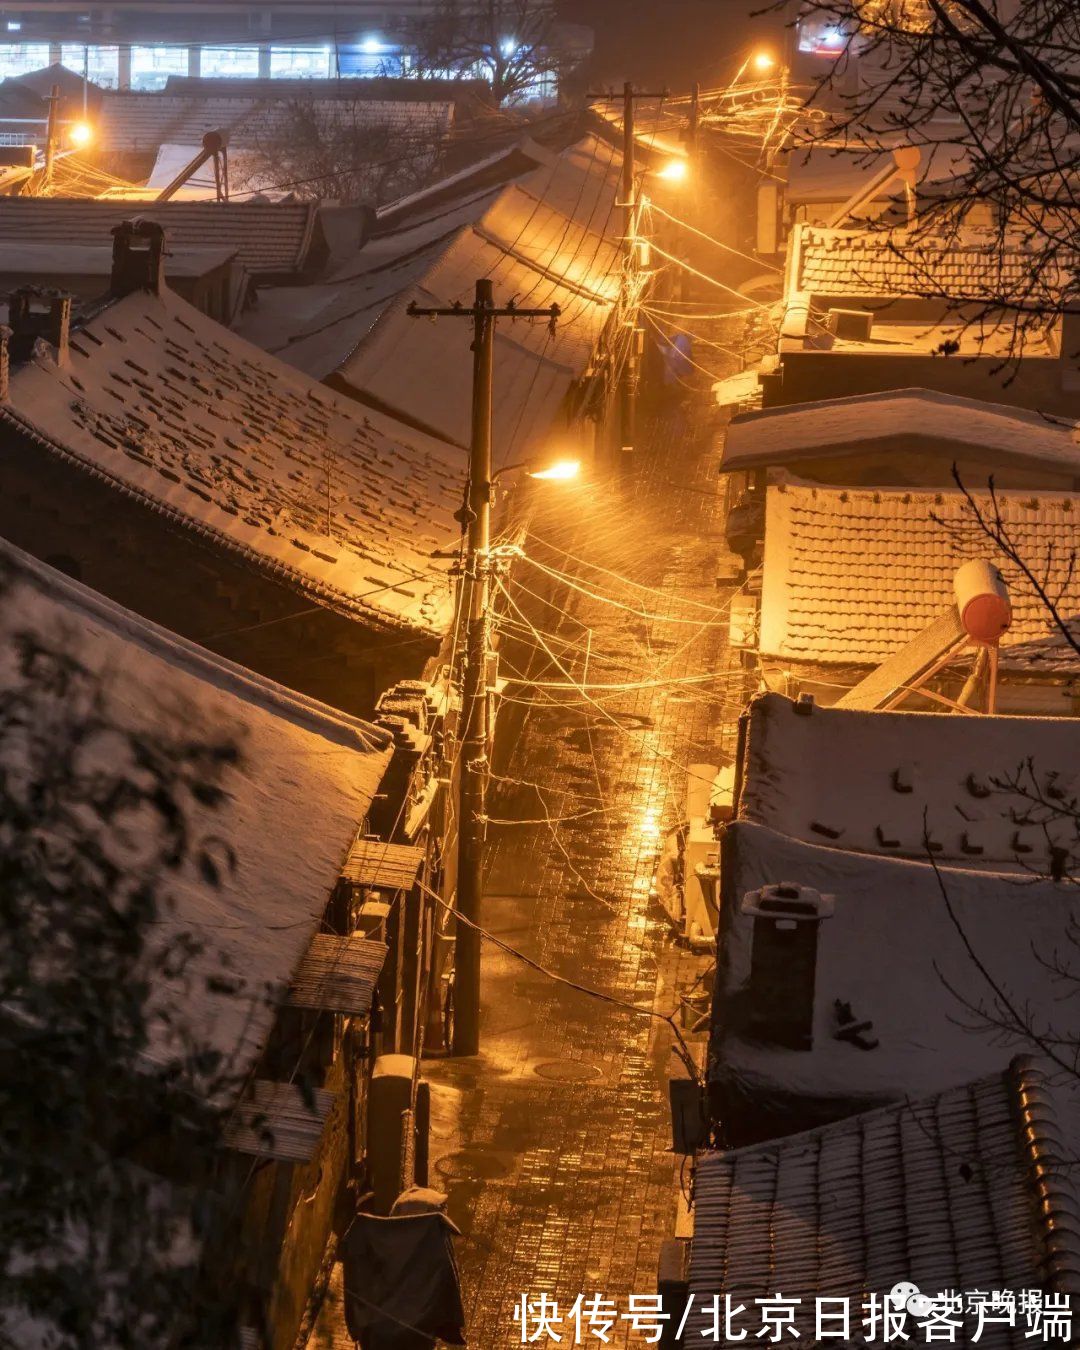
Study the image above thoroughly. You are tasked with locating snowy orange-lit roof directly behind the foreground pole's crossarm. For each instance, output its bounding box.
[247,140,620,463]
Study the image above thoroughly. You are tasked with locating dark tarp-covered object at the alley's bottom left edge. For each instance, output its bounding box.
[342,1214,464,1350]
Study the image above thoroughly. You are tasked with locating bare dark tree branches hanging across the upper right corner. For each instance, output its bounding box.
[795,0,1080,348]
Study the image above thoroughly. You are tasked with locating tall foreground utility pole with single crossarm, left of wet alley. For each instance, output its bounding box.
[408,278,560,1054]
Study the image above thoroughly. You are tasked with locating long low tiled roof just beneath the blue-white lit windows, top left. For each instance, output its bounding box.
[95,90,454,151]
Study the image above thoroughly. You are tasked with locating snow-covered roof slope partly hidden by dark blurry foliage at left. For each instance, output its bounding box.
[0,531,390,1076]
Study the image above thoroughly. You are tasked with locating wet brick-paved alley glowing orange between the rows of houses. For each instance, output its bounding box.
[428,400,745,1347]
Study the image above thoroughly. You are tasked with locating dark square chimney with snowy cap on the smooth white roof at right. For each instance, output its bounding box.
[740,882,834,1050]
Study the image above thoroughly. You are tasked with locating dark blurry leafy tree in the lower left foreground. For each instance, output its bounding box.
[0,578,255,1350]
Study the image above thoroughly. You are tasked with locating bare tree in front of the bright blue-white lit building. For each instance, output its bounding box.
[406,0,568,108]
